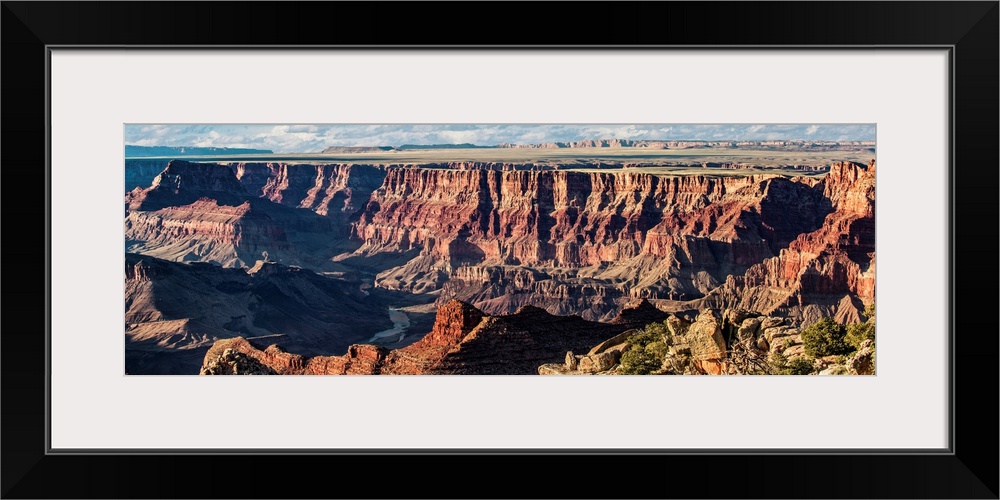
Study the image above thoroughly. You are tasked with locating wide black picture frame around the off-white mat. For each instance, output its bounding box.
[0,1,1000,498]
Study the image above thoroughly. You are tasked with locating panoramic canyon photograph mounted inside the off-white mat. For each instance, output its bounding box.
[124,123,876,376]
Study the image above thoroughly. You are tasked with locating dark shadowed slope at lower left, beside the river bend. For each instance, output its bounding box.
[125,254,392,374]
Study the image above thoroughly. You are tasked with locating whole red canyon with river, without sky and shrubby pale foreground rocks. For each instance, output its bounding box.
[124,148,875,374]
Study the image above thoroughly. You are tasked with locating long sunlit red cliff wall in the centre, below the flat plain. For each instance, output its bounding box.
[352,169,830,319]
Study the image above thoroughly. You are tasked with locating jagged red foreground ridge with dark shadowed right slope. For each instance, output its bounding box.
[201,300,667,375]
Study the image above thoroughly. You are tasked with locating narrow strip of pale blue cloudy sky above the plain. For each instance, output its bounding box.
[125,124,875,153]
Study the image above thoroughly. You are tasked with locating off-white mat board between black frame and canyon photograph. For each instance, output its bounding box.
[52,50,948,448]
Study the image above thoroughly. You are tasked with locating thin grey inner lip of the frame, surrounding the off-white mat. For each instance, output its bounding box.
[43,44,956,456]
